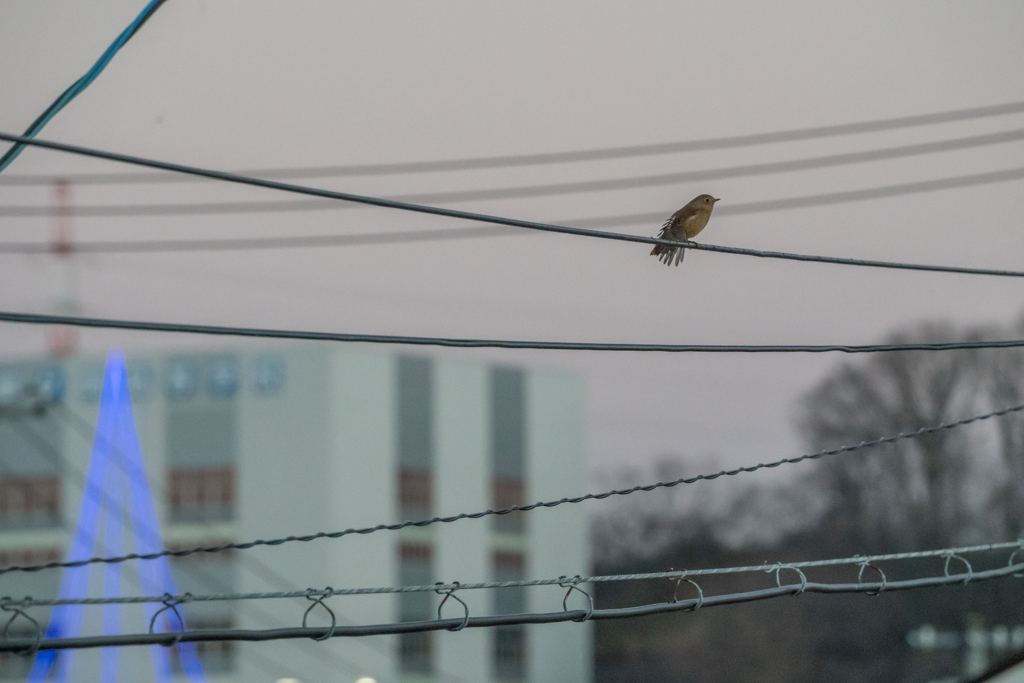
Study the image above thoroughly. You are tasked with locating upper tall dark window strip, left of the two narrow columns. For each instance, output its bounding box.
[397,356,434,519]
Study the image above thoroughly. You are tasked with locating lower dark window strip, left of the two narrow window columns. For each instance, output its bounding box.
[398,543,434,674]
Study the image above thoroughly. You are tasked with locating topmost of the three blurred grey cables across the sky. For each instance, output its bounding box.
[0,102,1024,185]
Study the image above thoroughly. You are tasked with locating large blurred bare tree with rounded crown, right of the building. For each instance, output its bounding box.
[800,324,995,549]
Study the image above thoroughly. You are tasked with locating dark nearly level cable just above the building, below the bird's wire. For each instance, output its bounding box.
[0,311,1024,353]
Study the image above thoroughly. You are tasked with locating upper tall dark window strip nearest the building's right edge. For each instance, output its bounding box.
[490,368,526,533]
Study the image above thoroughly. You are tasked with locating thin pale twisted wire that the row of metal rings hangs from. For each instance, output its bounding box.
[4,540,1024,607]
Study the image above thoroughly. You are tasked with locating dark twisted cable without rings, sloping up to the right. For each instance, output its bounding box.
[0,404,1024,574]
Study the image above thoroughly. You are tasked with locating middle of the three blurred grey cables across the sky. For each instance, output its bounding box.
[6,129,1024,218]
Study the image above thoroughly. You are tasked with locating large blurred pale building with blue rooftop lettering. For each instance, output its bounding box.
[0,347,592,683]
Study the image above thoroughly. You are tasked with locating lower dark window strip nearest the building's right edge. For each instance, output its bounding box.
[492,551,526,682]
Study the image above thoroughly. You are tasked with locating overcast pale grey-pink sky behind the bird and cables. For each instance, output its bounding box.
[0,0,1024,485]
